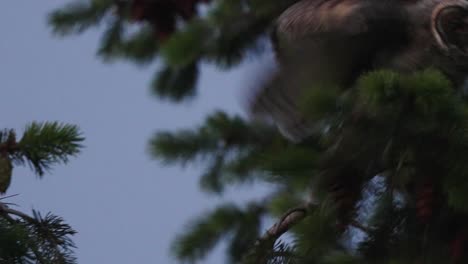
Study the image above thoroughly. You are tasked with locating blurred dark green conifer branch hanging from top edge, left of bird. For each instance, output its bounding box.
[49,0,295,101]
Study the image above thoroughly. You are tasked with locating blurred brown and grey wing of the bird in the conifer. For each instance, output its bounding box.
[251,0,403,142]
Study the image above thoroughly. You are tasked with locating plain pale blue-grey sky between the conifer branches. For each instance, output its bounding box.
[0,0,270,264]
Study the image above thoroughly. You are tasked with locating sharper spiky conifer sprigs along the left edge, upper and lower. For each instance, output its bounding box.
[0,122,83,264]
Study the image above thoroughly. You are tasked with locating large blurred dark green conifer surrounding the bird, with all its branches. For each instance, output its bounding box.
[50,0,468,264]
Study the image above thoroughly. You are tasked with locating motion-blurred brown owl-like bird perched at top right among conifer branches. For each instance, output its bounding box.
[251,0,468,142]
